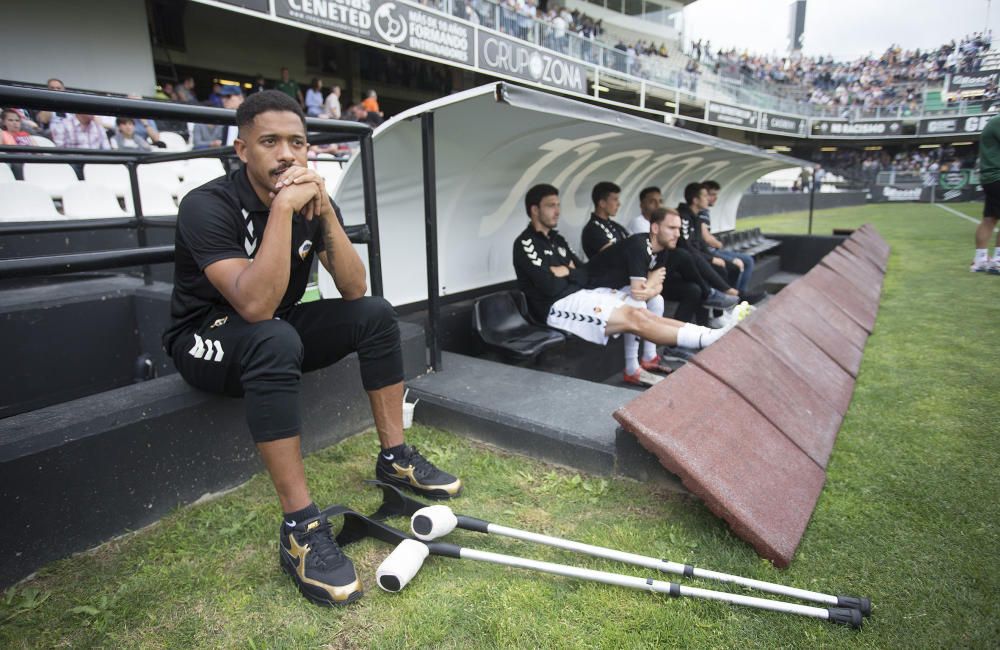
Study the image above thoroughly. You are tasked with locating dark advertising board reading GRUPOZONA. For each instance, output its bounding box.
[479,29,587,94]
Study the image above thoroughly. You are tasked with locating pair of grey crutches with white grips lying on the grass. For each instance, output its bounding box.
[358,481,871,628]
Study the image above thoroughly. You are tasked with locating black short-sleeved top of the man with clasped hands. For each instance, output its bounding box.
[163,165,344,353]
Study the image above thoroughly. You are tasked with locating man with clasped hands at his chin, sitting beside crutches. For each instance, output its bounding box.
[164,91,461,605]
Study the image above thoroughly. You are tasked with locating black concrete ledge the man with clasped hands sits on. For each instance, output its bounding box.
[0,323,426,586]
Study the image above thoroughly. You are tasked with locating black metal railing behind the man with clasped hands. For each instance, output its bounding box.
[0,85,383,296]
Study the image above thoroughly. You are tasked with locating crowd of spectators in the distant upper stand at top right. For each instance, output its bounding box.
[689,31,997,115]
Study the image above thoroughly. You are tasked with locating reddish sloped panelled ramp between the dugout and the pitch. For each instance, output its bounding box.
[614,225,889,567]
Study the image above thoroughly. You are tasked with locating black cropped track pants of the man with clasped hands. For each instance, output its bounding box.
[170,297,403,442]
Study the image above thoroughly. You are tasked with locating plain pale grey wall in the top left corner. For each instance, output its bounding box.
[0,0,156,95]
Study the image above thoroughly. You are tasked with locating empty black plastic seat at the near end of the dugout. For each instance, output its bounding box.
[472,291,566,360]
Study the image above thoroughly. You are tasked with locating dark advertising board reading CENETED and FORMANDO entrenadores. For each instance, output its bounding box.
[274,0,474,65]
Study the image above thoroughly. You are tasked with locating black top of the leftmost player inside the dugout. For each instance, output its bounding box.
[513,223,587,323]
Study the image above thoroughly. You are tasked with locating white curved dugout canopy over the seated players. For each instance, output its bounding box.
[321,82,813,305]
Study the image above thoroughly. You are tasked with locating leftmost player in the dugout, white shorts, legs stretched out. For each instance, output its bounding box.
[513,184,725,349]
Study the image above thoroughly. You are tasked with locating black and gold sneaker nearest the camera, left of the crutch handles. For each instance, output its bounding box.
[278,515,364,606]
